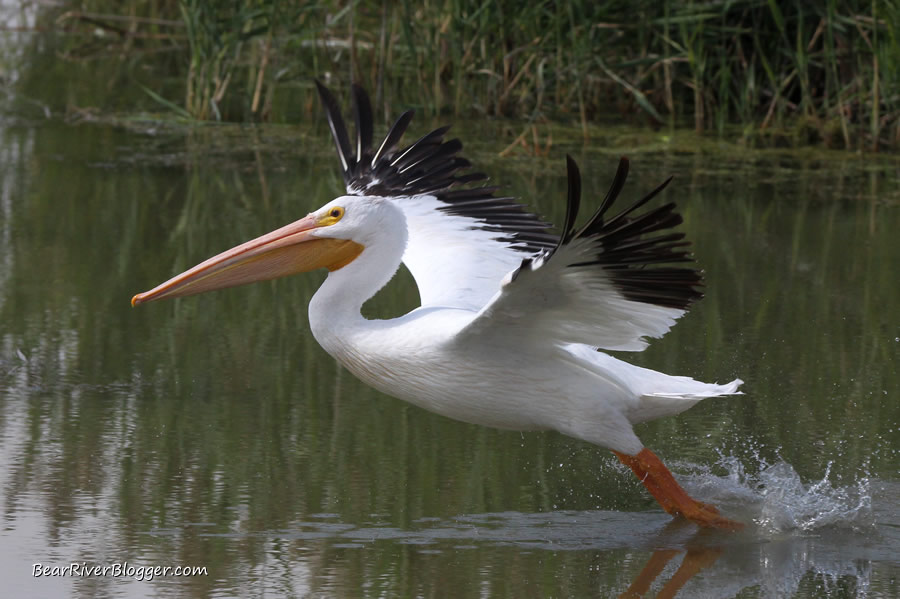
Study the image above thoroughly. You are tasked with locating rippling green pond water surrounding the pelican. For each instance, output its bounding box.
[0,119,900,597]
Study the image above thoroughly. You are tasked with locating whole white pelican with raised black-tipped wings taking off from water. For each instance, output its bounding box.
[132,82,743,530]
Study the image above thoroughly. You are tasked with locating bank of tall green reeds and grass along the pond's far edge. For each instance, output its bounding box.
[17,0,900,151]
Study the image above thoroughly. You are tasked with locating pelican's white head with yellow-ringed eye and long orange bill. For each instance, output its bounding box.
[131,196,405,306]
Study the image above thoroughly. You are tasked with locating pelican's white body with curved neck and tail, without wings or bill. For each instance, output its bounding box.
[309,197,737,454]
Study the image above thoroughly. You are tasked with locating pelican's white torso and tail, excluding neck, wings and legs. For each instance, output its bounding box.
[320,309,739,454]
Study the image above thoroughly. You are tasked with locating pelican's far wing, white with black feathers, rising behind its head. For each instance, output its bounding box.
[316,81,557,311]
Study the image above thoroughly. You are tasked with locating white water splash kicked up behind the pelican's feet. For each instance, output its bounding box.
[684,451,875,535]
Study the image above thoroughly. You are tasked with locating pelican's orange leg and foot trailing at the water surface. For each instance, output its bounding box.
[613,447,744,530]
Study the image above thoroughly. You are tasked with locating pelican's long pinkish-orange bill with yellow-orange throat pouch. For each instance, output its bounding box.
[131,214,363,306]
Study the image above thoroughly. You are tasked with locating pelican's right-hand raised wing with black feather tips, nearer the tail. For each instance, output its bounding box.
[457,156,702,351]
